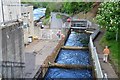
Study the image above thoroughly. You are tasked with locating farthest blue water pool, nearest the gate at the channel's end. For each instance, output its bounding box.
[65,32,89,47]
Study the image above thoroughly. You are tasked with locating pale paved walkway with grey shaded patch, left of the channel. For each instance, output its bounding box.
[25,40,58,78]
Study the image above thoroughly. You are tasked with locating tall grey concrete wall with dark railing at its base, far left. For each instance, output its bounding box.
[0,22,25,78]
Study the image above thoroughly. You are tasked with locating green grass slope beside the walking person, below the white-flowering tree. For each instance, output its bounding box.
[100,36,120,75]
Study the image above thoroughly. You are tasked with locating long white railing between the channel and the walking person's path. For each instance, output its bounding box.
[89,29,104,78]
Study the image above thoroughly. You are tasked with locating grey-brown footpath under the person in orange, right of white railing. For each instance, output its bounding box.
[94,31,118,80]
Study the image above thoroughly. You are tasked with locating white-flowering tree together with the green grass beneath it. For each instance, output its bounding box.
[96,2,120,74]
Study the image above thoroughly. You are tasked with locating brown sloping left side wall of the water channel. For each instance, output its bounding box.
[34,29,70,78]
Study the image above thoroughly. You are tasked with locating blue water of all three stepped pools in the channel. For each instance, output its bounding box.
[45,31,93,80]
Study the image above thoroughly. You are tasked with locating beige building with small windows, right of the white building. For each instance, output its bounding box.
[21,4,34,44]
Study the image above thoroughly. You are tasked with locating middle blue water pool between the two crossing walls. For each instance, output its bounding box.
[56,49,90,65]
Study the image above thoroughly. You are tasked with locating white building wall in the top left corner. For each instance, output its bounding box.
[0,0,21,23]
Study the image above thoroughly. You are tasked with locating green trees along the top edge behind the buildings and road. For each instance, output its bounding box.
[22,0,93,14]
